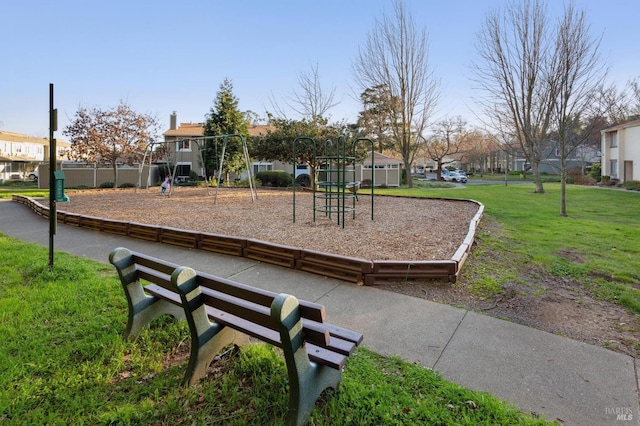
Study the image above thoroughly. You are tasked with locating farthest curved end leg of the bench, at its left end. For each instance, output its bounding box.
[109,247,185,340]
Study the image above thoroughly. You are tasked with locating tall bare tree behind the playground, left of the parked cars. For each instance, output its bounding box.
[353,0,440,188]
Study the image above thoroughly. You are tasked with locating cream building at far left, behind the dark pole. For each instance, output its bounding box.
[0,131,71,182]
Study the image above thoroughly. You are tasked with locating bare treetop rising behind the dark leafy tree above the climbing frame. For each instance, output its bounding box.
[271,64,339,123]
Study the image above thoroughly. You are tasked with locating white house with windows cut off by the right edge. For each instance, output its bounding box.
[600,120,640,182]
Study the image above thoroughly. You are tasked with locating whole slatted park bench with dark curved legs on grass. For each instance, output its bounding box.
[109,248,363,425]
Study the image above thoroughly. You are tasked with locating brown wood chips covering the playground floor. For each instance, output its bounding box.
[58,187,478,260]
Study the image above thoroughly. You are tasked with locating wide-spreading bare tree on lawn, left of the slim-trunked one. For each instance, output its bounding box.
[474,0,556,193]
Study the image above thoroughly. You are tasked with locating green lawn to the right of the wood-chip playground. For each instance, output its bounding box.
[376,183,640,313]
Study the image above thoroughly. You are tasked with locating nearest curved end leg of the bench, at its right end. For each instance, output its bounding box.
[271,294,342,426]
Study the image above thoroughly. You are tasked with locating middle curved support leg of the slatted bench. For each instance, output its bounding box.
[171,267,249,385]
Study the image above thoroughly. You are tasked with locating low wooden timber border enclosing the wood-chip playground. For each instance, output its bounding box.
[12,194,484,285]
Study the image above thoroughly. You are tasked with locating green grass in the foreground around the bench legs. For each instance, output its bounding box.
[0,234,545,425]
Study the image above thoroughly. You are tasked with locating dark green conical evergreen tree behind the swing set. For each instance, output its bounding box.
[204,78,249,181]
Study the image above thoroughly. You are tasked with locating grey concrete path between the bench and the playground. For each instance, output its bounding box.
[0,200,640,425]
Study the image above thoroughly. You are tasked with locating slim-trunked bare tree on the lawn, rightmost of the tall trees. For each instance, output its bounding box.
[552,4,606,216]
